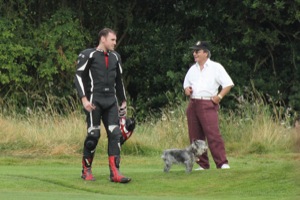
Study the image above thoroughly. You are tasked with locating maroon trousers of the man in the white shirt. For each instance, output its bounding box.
[186,99,228,169]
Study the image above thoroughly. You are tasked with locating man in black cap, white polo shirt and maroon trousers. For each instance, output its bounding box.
[183,41,234,170]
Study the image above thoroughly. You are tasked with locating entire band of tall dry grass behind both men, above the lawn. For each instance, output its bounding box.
[0,97,300,155]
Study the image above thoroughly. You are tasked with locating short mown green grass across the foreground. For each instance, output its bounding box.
[0,154,300,200]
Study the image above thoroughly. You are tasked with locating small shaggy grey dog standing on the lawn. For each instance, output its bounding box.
[161,140,207,173]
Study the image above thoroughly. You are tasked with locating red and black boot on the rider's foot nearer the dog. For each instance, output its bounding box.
[108,156,131,183]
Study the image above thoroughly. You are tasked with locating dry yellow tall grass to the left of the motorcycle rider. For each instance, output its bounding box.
[0,111,85,154]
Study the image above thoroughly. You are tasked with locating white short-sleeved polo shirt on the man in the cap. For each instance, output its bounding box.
[183,59,234,98]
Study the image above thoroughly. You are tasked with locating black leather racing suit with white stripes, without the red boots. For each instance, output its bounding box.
[74,48,126,165]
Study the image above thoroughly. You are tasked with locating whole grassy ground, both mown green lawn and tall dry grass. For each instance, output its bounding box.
[0,99,300,200]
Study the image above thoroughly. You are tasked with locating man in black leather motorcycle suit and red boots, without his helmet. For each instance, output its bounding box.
[74,28,133,183]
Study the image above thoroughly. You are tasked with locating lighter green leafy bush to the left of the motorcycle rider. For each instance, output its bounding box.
[0,5,88,112]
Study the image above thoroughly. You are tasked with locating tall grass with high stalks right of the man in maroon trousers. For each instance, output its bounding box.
[220,89,300,154]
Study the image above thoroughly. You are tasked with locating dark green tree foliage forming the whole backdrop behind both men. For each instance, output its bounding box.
[0,0,300,117]
